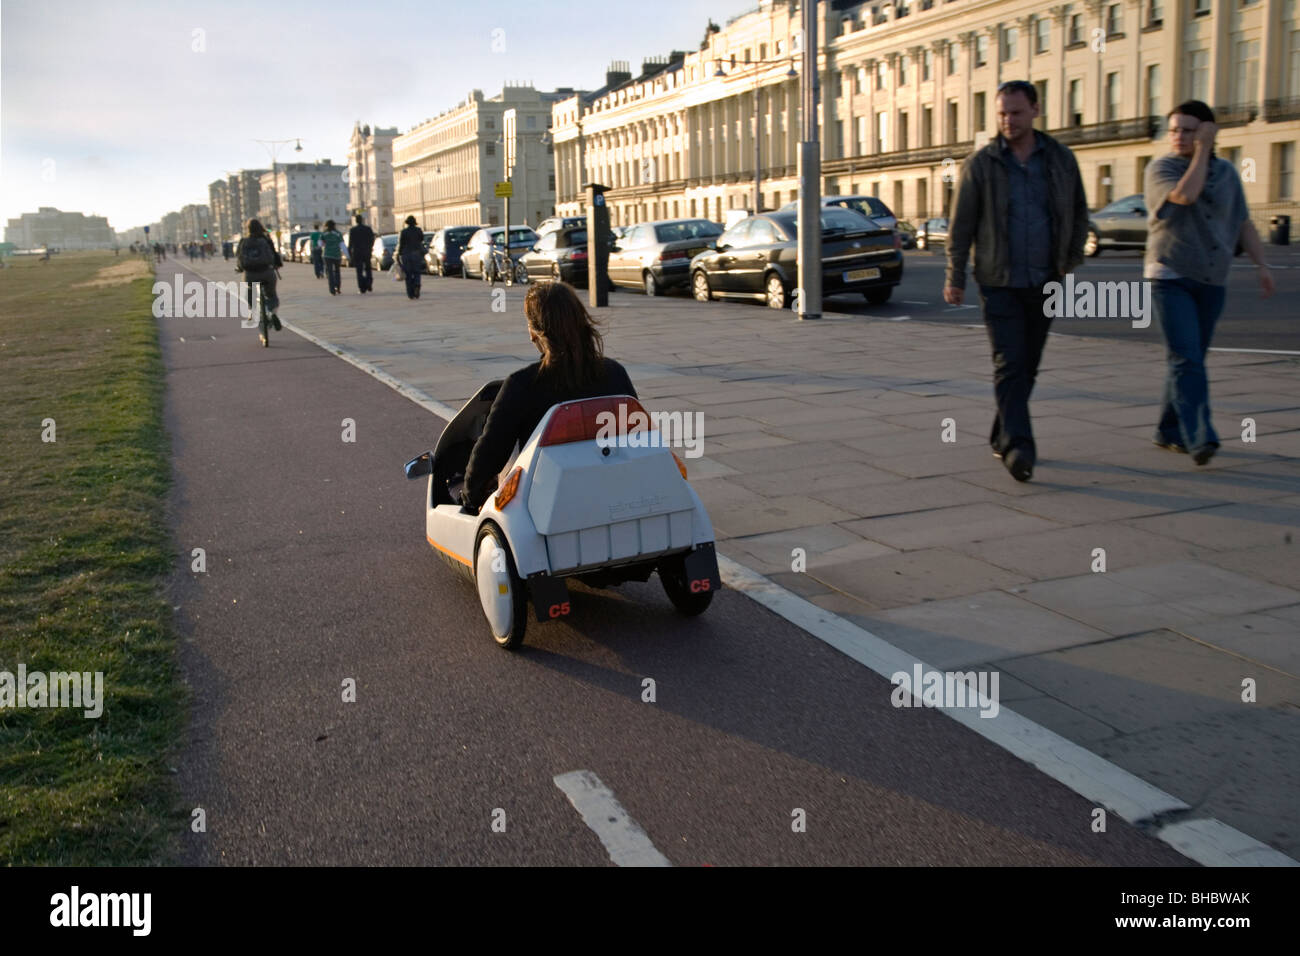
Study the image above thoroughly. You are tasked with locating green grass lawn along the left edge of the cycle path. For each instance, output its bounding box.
[0,251,186,865]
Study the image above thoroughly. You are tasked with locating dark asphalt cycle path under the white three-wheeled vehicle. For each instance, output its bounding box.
[160,261,1187,866]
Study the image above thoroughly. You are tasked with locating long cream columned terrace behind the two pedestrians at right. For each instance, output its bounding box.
[553,0,1300,225]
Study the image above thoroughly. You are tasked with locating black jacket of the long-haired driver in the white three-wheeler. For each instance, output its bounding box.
[465,359,637,509]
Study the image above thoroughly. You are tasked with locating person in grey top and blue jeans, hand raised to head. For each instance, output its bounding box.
[1143,100,1274,466]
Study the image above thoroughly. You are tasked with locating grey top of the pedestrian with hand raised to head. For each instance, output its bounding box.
[1143,153,1249,285]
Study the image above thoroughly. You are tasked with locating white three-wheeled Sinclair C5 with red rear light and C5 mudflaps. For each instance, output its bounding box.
[406,381,722,649]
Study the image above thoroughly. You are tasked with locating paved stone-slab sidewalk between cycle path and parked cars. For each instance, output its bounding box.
[256,264,1300,857]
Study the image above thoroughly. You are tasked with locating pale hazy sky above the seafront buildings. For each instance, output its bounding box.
[0,0,758,232]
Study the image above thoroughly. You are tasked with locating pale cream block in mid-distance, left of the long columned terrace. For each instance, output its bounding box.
[393,85,571,230]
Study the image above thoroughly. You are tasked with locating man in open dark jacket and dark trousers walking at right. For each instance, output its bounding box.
[944,79,1088,481]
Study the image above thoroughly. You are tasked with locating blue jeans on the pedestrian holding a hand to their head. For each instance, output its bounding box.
[1152,278,1227,454]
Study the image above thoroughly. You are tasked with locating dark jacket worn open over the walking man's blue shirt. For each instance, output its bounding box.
[945,130,1088,289]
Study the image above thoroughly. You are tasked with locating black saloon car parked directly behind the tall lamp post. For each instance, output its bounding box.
[690,207,902,308]
